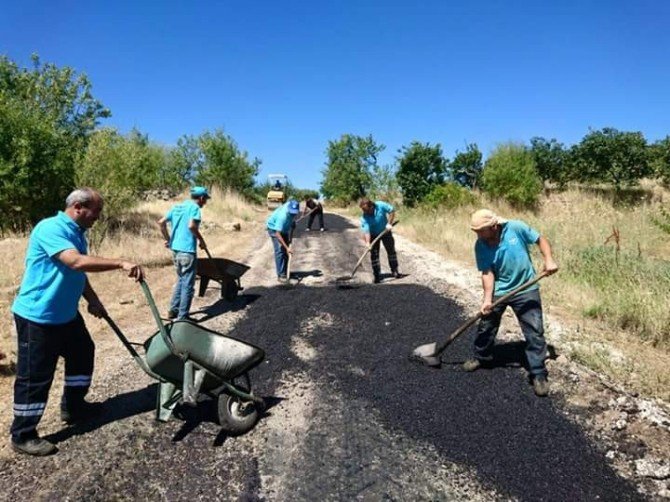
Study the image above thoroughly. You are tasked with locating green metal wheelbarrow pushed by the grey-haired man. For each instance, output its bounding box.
[105,281,265,435]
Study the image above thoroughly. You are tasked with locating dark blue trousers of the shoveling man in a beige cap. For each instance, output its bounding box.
[475,289,547,377]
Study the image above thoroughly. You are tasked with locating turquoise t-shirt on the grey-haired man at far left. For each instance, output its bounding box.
[12,211,87,324]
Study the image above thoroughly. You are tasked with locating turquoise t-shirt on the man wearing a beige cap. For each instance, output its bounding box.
[475,220,540,296]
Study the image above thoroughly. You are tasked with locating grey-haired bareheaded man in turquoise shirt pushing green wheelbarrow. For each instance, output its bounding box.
[11,188,144,456]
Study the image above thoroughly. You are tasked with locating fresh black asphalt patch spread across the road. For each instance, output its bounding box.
[230,281,639,500]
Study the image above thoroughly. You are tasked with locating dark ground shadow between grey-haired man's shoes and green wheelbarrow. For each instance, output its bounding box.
[45,383,158,443]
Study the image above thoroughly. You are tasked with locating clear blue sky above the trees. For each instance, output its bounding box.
[0,0,670,188]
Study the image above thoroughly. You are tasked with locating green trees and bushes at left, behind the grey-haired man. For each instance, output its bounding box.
[0,55,261,232]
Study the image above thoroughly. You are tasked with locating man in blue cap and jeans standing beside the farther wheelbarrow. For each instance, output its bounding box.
[158,186,209,319]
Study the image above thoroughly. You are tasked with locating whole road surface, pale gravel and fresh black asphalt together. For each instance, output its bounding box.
[0,215,641,501]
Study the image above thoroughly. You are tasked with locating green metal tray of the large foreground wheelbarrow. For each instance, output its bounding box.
[144,320,265,390]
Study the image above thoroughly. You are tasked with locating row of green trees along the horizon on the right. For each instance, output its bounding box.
[321,127,670,207]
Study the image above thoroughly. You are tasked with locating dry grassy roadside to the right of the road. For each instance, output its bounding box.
[346,188,670,401]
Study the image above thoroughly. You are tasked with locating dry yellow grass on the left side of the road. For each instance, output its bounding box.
[0,191,267,375]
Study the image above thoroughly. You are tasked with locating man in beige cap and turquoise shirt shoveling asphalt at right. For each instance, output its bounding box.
[463,209,558,396]
